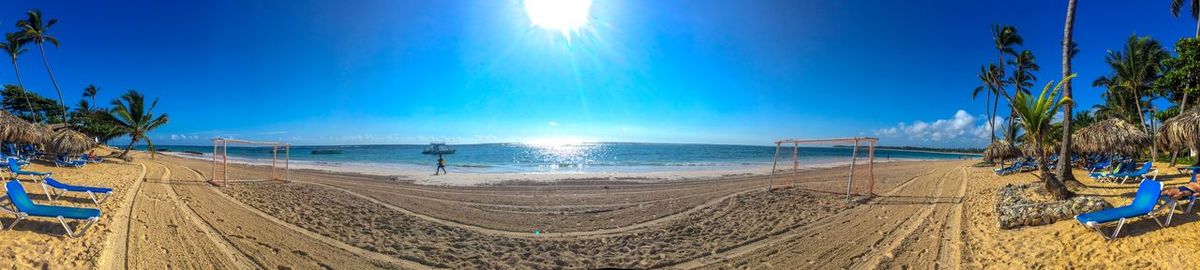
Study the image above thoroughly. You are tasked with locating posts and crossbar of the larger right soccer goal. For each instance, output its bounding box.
[767,137,880,203]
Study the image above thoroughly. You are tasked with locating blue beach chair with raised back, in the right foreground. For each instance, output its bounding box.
[1075,180,1171,240]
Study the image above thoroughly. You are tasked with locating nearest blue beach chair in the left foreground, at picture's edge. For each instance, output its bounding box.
[4,180,100,238]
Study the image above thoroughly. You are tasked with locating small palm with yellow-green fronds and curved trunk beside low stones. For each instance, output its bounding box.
[1012,76,1075,199]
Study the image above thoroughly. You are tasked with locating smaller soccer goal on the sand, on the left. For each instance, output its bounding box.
[209,138,292,186]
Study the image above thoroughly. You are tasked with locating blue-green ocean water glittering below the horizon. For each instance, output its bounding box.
[139,143,971,173]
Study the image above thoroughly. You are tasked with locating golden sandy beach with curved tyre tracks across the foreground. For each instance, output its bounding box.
[0,148,1200,269]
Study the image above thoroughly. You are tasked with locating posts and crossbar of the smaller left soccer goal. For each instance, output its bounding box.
[209,138,292,186]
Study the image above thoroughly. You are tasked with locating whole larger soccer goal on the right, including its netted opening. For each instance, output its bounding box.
[767,137,880,203]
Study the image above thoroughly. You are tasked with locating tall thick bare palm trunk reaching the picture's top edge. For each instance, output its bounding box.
[1058,0,1080,186]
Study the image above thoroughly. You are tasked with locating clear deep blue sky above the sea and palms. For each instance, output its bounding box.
[0,0,1195,146]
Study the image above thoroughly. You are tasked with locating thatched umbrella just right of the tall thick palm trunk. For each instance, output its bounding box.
[1070,119,1151,155]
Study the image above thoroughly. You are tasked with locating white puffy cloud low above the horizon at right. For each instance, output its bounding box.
[875,109,1004,145]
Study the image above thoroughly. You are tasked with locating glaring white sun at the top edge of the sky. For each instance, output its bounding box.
[524,0,592,36]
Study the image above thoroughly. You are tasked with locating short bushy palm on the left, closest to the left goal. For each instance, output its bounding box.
[104,89,168,158]
